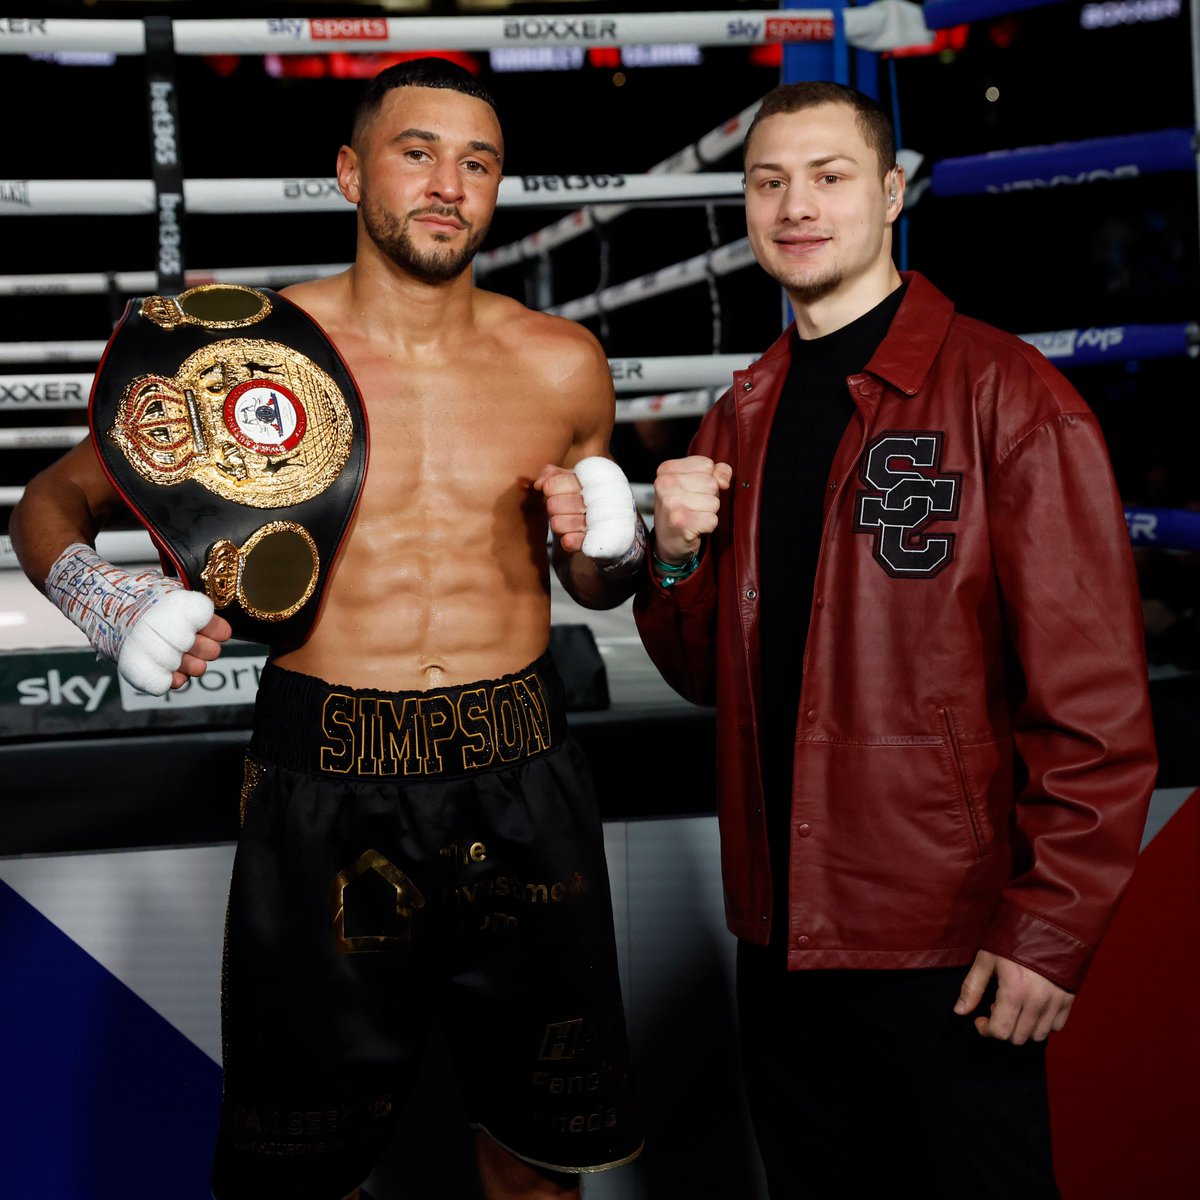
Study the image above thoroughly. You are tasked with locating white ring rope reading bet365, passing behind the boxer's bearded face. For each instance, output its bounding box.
[0,170,742,216]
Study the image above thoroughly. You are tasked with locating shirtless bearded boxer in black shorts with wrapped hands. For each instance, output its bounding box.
[11,59,643,1200]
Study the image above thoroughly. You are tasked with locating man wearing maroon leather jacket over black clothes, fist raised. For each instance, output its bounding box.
[635,84,1156,1200]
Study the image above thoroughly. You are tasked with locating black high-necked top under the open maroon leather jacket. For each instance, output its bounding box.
[758,286,905,900]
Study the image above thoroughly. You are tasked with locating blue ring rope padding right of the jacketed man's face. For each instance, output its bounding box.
[930,130,1196,196]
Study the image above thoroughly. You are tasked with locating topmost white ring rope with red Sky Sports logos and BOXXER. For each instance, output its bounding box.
[0,0,934,55]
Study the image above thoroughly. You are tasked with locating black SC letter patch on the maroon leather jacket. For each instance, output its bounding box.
[854,430,962,580]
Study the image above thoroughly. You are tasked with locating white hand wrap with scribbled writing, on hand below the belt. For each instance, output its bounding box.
[46,541,214,696]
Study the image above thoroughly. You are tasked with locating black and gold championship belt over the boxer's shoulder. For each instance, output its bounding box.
[88,283,367,649]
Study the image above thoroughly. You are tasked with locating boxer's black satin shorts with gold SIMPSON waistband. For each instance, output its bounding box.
[212,655,642,1200]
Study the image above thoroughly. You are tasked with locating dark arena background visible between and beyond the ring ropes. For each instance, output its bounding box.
[0,0,1200,748]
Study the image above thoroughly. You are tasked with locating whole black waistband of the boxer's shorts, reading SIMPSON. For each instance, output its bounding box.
[250,652,566,782]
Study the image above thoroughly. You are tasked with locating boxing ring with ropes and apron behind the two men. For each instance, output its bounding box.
[0,0,1200,1200]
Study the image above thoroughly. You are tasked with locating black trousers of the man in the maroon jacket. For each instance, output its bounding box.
[737,942,1058,1200]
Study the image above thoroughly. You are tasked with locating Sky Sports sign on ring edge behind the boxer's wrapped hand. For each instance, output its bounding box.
[0,642,266,742]
